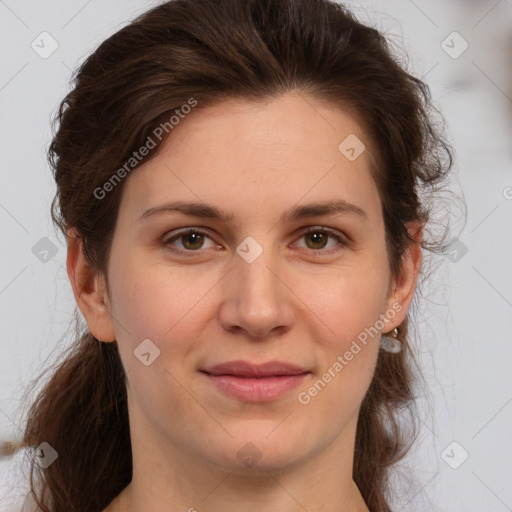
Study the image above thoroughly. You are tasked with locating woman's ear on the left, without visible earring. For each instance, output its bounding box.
[66,229,116,342]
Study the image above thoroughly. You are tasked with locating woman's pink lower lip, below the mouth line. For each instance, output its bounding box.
[206,373,308,402]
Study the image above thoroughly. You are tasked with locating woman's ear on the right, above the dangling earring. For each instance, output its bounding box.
[388,221,423,330]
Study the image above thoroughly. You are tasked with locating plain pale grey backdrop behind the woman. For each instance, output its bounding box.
[0,0,512,512]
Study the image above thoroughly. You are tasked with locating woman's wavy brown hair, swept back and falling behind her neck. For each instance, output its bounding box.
[13,0,452,512]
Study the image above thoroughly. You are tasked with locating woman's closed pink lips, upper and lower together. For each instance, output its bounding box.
[201,361,311,402]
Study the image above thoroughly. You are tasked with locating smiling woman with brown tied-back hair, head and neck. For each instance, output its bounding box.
[13,0,452,512]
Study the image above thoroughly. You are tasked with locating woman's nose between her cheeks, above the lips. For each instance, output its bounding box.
[219,250,295,340]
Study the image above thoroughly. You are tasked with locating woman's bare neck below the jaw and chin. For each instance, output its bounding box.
[104,388,370,512]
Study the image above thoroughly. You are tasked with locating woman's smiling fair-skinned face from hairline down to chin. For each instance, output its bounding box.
[88,93,412,471]
